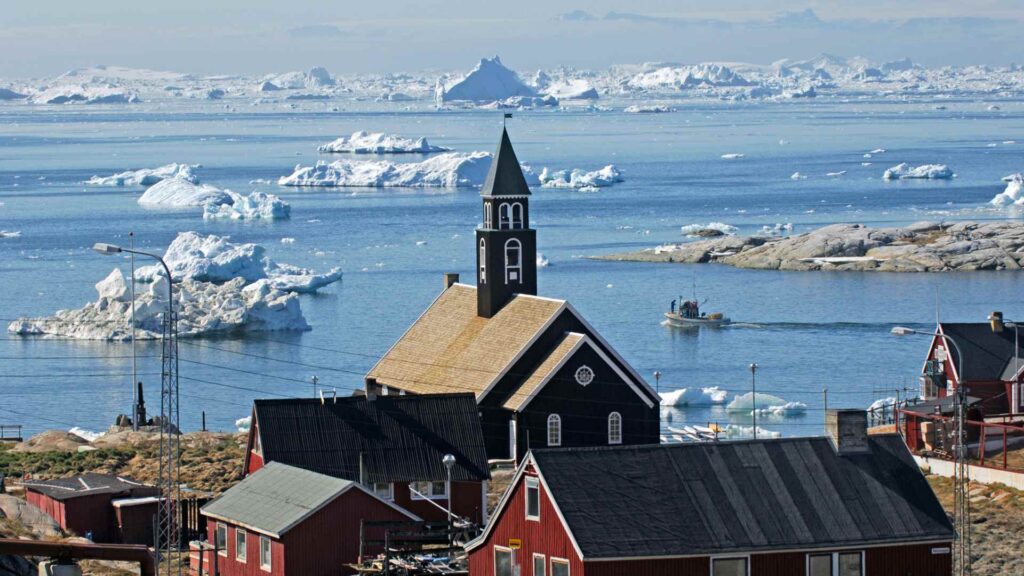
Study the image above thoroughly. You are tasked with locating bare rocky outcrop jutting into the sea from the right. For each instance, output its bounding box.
[594,220,1024,272]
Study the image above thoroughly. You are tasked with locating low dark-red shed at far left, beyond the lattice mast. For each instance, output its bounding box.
[24,472,160,544]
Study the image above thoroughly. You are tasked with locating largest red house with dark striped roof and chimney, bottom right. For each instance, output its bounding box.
[466,411,954,576]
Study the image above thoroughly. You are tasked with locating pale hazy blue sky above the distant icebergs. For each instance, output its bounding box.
[0,0,1024,78]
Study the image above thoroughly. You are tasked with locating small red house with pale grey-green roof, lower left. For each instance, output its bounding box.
[191,462,420,576]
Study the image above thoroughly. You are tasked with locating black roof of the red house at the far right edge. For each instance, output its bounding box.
[941,322,1024,381]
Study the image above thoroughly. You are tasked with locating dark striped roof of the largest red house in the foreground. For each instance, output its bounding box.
[532,435,953,559]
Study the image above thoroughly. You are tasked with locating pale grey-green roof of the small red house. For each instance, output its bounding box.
[203,462,376,538]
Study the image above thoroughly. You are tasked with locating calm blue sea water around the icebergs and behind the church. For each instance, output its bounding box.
[0,101,1024,435]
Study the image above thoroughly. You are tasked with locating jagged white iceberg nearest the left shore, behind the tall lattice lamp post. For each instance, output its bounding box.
[7,269,309,340]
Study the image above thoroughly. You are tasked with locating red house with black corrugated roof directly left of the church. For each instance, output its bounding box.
[244,394,490,525]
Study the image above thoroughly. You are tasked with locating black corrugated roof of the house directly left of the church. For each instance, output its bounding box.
[254,394,490,482]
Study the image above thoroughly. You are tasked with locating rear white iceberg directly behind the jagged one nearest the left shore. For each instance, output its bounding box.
[135,232,342,293]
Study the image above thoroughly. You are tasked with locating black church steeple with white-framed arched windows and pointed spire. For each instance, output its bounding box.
[476,128,537,318]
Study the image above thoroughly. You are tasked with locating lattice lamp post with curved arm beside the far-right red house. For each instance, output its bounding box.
[891,323,970,576]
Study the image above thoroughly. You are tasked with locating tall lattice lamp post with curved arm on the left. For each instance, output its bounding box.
[92,242,181,576]
